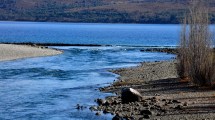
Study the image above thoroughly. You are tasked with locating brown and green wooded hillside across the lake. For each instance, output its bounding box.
[0,0,215,24]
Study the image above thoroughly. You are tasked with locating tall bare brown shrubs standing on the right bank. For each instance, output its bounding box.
[178,0,215,86]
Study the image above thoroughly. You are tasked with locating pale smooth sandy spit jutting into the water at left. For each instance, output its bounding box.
[0,44,62,61]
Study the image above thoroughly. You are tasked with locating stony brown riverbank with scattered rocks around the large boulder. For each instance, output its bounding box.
[92,60,215,120]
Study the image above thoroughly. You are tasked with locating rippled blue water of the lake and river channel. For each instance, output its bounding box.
[0,22,179,120]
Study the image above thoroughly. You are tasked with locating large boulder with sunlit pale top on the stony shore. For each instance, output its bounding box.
[121,88,142,103]
